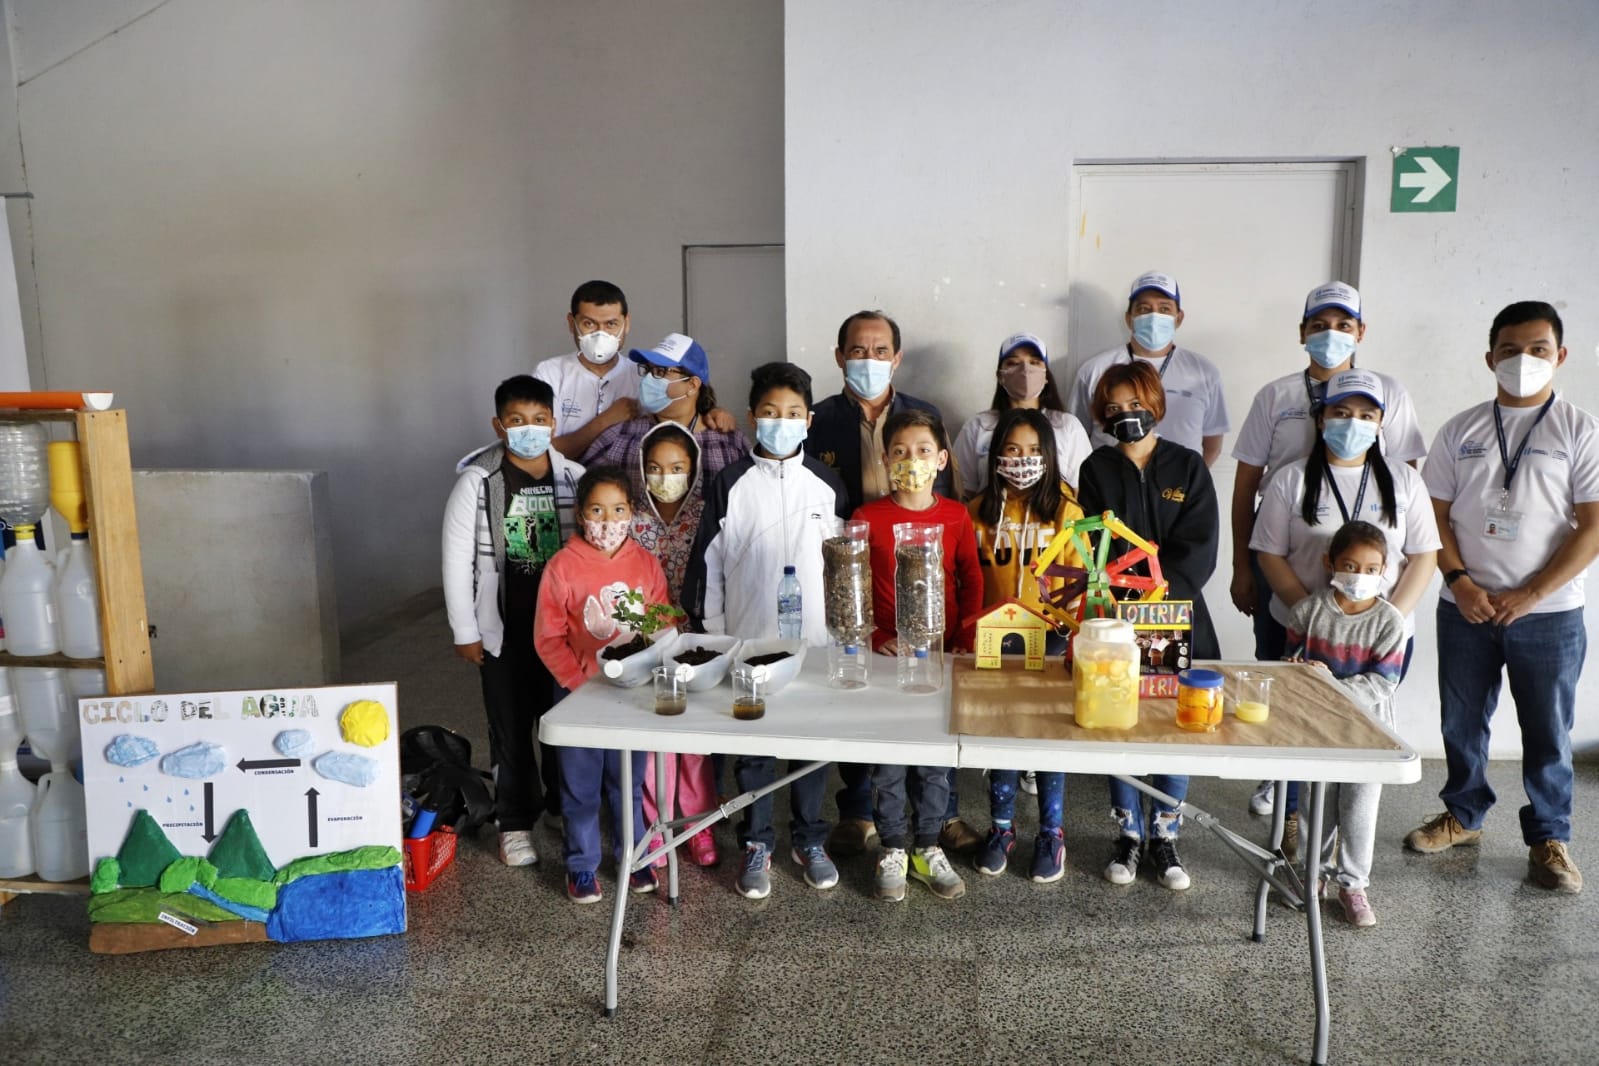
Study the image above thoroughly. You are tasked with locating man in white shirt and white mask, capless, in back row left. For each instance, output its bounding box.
[532,281,638,459]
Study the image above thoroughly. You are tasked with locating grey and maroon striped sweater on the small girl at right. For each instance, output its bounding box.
[1287,587,1406,726]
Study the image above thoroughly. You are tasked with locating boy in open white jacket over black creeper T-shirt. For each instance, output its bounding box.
[443,374,584,866]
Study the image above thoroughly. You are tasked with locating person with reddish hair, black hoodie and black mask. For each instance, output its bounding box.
[1078,360,1222,890]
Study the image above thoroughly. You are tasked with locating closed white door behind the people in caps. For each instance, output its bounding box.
[1068,161,1361,658]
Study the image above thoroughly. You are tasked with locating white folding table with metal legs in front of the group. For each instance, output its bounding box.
[539,657,1422,1066]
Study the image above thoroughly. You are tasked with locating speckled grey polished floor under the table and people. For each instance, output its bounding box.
[0,614,1599,1066]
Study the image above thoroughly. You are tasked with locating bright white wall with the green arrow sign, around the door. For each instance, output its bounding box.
[785,0,1599,754]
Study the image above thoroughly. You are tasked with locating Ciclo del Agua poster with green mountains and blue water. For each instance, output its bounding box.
[78,684,405,953]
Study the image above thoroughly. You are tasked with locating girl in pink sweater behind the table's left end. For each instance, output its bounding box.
[532,467,670,903]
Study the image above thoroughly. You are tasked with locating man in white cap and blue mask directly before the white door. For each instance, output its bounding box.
[1067,270,1228,467]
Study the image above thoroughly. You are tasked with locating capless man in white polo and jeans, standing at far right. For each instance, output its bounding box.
[1406,300,1599,892]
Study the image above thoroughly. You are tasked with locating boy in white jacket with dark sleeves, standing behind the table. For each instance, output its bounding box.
[683,363,849,900]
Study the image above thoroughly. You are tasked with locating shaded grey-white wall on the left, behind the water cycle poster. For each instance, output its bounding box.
[9,0,782,625]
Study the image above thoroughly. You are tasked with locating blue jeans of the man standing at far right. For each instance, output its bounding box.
[1438,599,1588,844]
